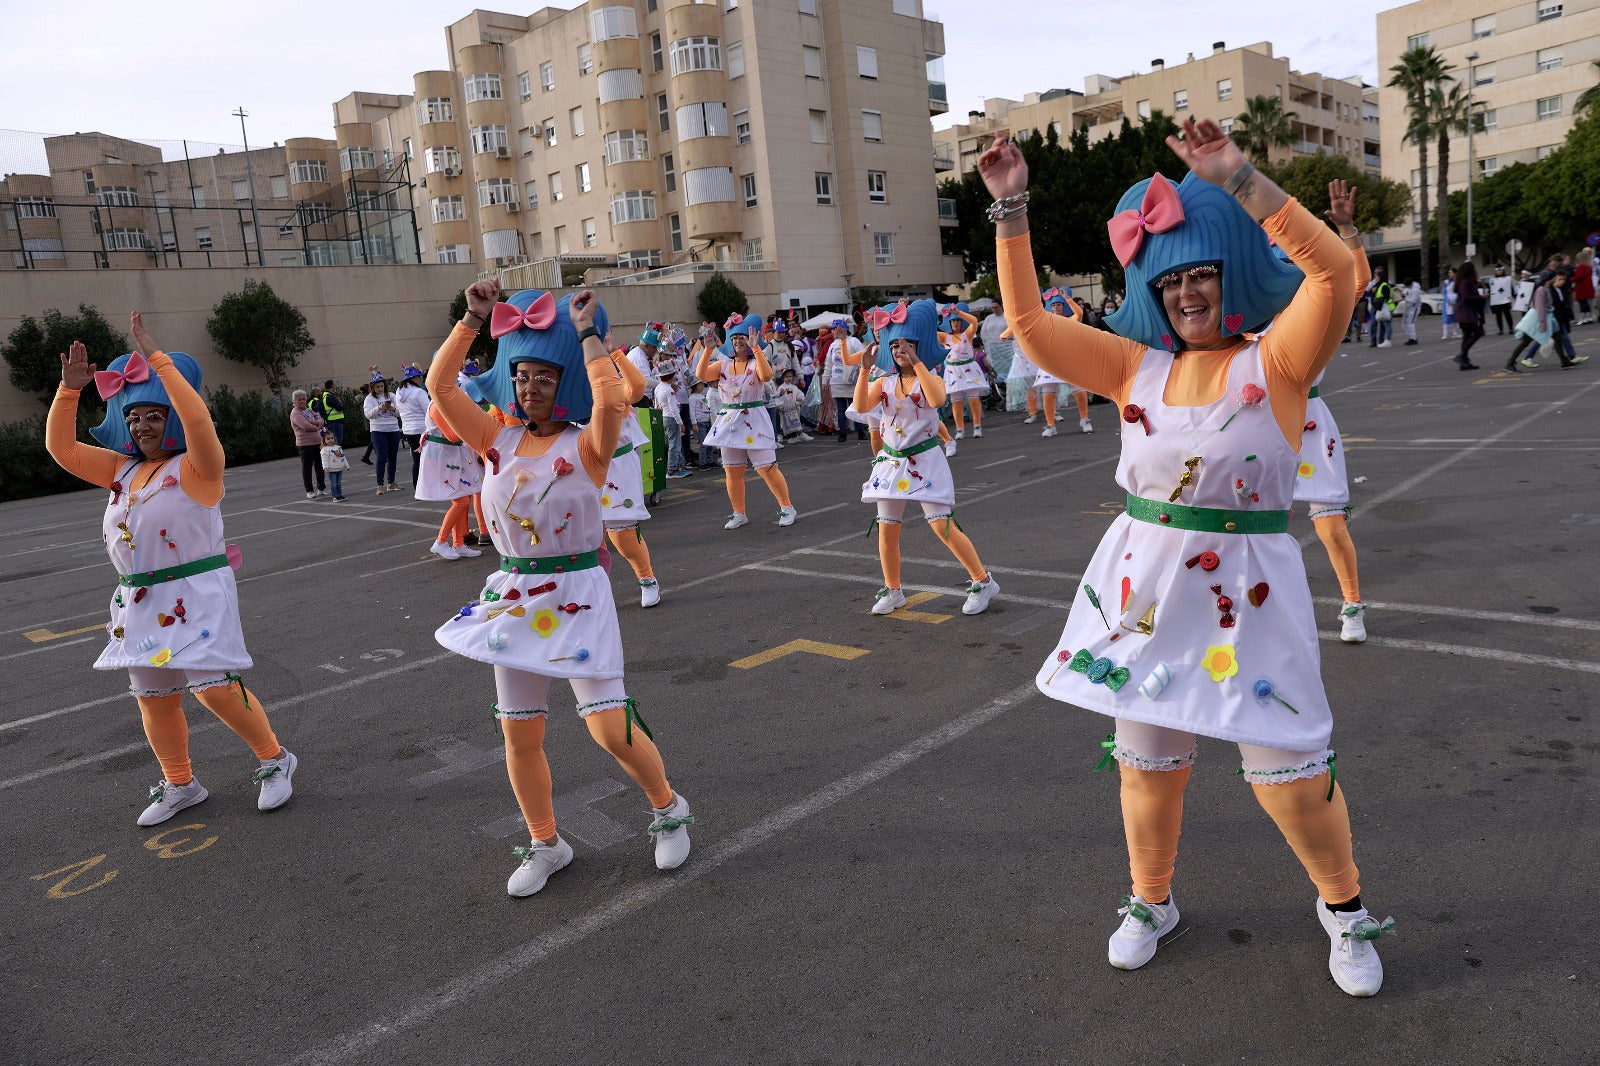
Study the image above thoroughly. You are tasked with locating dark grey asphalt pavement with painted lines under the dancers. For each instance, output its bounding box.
[0,328,1600,1066]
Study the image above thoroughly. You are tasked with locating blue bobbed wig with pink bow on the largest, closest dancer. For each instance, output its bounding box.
[1106,173,1306,352]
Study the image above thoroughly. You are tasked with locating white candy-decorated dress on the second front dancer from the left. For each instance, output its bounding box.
[434,426,622,677]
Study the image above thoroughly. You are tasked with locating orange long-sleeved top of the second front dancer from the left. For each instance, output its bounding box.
[427,322,627,488]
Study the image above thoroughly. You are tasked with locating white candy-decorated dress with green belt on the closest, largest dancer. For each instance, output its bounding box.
[1037,343,1333,751]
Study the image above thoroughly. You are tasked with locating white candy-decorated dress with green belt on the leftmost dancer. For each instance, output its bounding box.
[94,456,251,672]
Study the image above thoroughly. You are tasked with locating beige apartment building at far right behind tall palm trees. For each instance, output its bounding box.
[1374,0,1600,262]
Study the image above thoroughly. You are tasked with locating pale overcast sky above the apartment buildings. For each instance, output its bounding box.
[0,0,1398,173]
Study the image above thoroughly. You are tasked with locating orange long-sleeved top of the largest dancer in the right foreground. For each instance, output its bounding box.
[998,198,1355,450]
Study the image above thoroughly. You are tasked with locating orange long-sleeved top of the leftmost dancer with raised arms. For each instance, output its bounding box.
[45,344,227,507]
